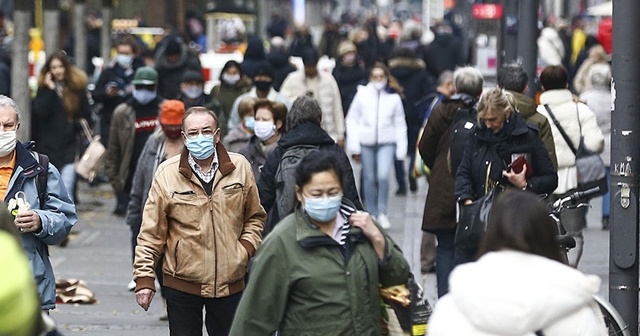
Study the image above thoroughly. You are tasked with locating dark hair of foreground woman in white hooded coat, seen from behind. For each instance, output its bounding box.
[478,190,564,262]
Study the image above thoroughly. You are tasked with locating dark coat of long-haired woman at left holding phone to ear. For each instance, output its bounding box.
[31,87,90,169]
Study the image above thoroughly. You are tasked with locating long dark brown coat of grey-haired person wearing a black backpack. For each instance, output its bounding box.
[418,99,465,231]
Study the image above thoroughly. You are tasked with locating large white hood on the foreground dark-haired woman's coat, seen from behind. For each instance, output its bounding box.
[449,251,600,335]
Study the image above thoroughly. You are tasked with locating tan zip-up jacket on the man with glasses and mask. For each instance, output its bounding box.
[133,143,266,298]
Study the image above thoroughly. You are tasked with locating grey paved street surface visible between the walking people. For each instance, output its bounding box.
[50,172,609,336]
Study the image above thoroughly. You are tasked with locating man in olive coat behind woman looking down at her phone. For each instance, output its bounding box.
[498,63,558,169]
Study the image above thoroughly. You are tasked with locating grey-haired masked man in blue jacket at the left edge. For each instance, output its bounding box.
[0,95,78,311]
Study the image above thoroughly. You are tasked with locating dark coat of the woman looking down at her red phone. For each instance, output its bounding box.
[455,113,558,203]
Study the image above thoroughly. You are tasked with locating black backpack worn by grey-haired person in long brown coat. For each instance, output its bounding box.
[447,94,478,177]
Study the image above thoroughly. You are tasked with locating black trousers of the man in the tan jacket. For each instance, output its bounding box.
[164,287,242,336]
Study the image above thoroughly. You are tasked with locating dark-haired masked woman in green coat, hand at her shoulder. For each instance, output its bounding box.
[230,151,410,336]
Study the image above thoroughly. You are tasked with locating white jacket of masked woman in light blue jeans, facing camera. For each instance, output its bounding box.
[347,83,407,160]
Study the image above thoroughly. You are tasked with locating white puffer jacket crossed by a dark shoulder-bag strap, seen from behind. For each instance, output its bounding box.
[537,89,604,194]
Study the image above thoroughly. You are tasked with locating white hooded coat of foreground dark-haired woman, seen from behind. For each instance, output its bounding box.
[428,251,607,336]
